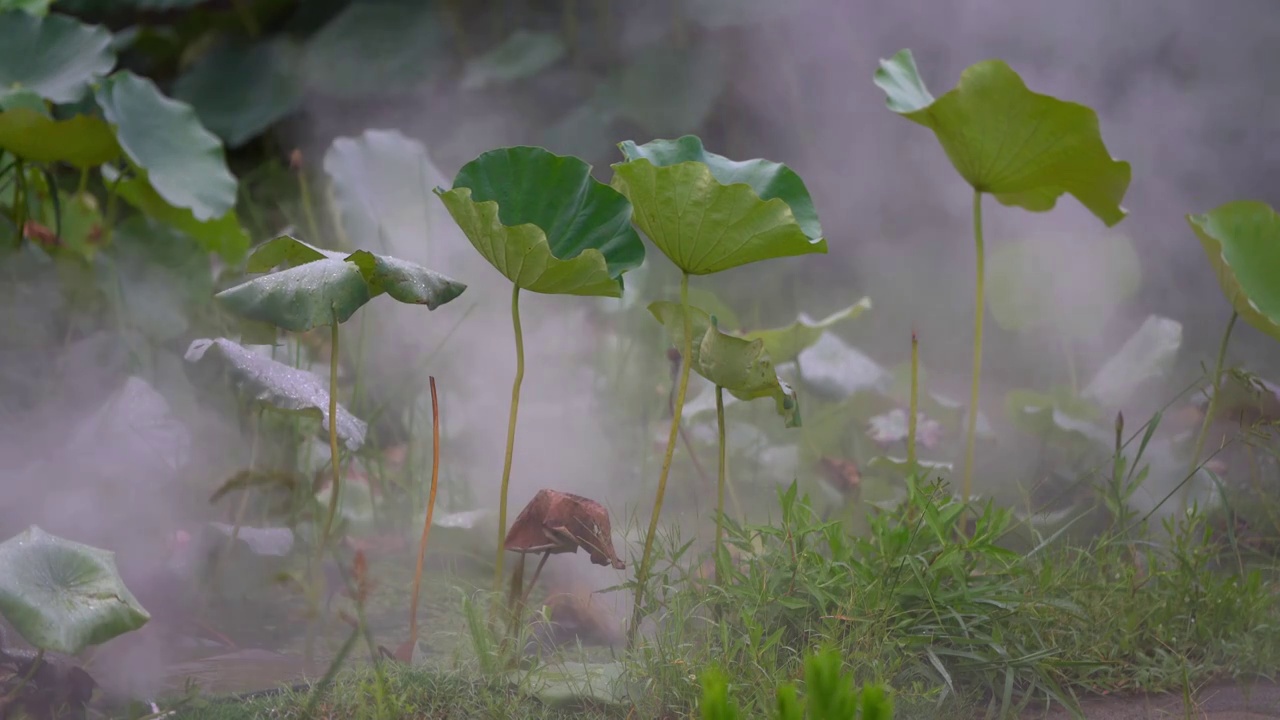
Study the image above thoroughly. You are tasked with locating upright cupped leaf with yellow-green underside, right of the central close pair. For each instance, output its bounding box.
[613,135,827,275]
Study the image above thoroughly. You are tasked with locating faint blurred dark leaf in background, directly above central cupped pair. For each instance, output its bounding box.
[603,42,728,137]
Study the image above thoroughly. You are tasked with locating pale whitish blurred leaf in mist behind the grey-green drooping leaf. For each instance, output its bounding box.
[324,129,452,254]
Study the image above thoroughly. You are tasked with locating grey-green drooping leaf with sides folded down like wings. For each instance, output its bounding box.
[216,236,466,332]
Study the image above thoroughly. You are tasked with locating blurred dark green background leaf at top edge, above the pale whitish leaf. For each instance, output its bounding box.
[302,0,451,97]
